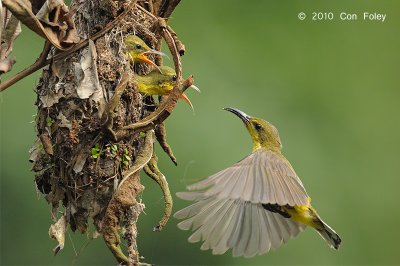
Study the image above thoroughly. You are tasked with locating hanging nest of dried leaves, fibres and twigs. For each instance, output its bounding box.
[26,0,193,264]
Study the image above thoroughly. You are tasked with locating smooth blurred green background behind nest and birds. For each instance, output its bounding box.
[0,0,400,265]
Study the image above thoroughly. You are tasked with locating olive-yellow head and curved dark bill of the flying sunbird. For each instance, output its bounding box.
[224,107,282,151]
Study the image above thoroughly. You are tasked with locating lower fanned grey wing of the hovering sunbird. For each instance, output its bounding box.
[174,197,305,257]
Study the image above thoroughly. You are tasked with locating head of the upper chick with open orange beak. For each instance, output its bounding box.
[124,35,165,68]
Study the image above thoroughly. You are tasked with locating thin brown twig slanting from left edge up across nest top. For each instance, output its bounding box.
[0,0,137,92]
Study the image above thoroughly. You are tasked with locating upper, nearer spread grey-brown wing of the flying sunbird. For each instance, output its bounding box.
[183,149,309,206]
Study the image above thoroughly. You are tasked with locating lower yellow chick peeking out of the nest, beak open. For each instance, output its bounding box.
[136,66,200,109]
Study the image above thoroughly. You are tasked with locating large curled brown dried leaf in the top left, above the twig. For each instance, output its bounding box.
[2,0,80,50]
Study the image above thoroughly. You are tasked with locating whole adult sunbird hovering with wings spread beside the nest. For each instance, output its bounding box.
[174,108,341,257]
